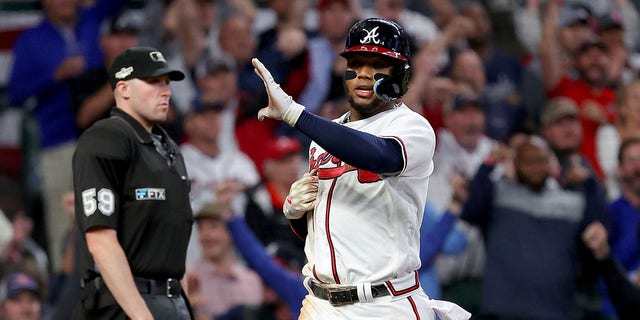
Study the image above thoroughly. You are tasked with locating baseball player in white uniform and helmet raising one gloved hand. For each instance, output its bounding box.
[253,18,470,320]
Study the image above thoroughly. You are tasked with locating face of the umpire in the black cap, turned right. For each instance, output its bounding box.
[127,75,171,129]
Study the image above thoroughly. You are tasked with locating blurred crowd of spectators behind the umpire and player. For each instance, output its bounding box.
[0,0,640,320]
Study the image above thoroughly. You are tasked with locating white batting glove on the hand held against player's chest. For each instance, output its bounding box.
[282,170,318,219]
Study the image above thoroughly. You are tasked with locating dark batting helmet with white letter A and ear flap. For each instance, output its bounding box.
[340,18,411,101]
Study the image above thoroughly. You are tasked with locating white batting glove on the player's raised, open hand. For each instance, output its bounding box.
[251,58,304,127]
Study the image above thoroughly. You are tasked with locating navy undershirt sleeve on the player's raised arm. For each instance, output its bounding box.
[296,111,404,174]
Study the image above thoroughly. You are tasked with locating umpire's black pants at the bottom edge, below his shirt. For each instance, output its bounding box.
[74,282,192,320]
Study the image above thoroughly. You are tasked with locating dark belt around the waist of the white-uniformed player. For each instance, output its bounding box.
[309,279,389,306]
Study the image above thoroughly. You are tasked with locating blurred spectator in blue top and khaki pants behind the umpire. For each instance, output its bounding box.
[7,0,126,271]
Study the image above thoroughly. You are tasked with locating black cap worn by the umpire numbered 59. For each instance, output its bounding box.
[109,47,184,88]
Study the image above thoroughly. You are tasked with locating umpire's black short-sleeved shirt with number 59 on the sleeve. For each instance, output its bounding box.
[73,108,193,279]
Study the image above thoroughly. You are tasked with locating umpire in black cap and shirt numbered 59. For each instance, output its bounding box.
[73,47,193,319]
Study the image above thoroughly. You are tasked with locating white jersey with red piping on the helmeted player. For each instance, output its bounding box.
[303,104,435,285]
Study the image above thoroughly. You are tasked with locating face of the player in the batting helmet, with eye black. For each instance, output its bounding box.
[344,53,393,117]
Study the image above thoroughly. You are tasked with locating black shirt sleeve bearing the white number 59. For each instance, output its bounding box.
[73,122,132,232]
